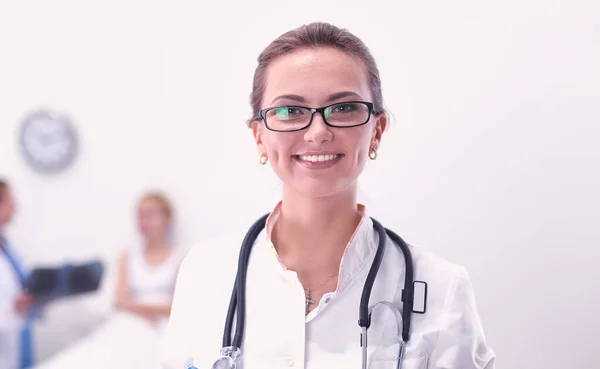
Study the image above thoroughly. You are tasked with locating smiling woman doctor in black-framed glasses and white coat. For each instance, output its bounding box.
[161,23,495,369]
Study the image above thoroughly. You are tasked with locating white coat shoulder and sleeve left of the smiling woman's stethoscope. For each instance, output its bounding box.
[159,232,244,369]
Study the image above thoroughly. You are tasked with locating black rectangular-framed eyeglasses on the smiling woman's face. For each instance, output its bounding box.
[258,101,376,132]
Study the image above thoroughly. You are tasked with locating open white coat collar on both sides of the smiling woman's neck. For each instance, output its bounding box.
[265,201,377,293]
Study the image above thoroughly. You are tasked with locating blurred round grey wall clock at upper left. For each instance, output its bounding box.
[19,110,78,173]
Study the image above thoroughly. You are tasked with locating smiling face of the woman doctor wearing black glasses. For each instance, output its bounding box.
[252,48,387,197]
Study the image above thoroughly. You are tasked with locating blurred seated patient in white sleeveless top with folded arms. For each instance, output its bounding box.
[29,192,185,369]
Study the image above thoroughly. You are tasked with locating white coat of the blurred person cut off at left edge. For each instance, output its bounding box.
[0,247,24,369]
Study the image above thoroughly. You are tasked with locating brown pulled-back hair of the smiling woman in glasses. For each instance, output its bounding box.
[247,22,385,125]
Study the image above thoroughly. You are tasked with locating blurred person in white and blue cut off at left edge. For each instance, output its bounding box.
[0,179,33,369]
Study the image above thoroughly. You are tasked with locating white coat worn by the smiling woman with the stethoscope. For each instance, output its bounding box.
[161,208,495,369]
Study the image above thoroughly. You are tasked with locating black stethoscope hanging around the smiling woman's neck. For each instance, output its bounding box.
[205,214,426,369]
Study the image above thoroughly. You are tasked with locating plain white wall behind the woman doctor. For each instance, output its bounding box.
[0,0,600,369]
